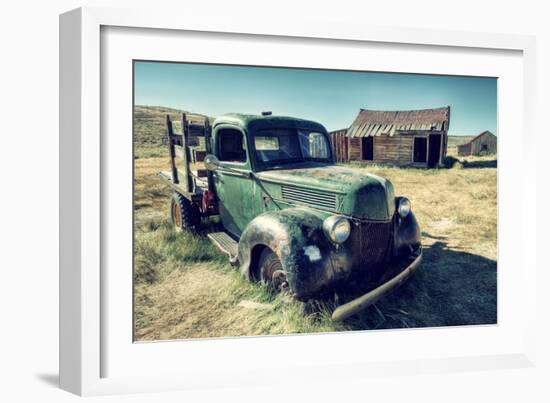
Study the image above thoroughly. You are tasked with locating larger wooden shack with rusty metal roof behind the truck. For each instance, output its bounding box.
[330,107,451,167]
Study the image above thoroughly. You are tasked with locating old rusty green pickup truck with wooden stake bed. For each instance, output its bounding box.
[159,113,422,320]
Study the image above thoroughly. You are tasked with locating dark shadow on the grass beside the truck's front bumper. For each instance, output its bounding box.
[346,241,497,330]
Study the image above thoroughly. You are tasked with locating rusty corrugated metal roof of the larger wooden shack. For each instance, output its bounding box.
[348,106,451,137]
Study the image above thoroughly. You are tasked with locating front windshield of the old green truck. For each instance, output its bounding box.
[254,129,330,164]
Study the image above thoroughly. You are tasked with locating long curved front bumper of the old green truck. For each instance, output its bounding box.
[332,247,422,322]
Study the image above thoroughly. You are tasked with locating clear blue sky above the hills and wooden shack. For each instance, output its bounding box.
[134,62,497,135]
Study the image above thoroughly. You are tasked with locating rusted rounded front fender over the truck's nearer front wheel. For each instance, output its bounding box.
[238,208,351,300]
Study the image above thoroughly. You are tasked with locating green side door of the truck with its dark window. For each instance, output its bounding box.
[213,126,257,237]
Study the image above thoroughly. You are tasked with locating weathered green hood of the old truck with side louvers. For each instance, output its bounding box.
[257,165,395,220]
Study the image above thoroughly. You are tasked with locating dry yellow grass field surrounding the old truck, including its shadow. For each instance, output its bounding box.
[134,106,497,341]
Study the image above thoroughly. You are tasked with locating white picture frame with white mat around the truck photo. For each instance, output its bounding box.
[60,8,537,395]
